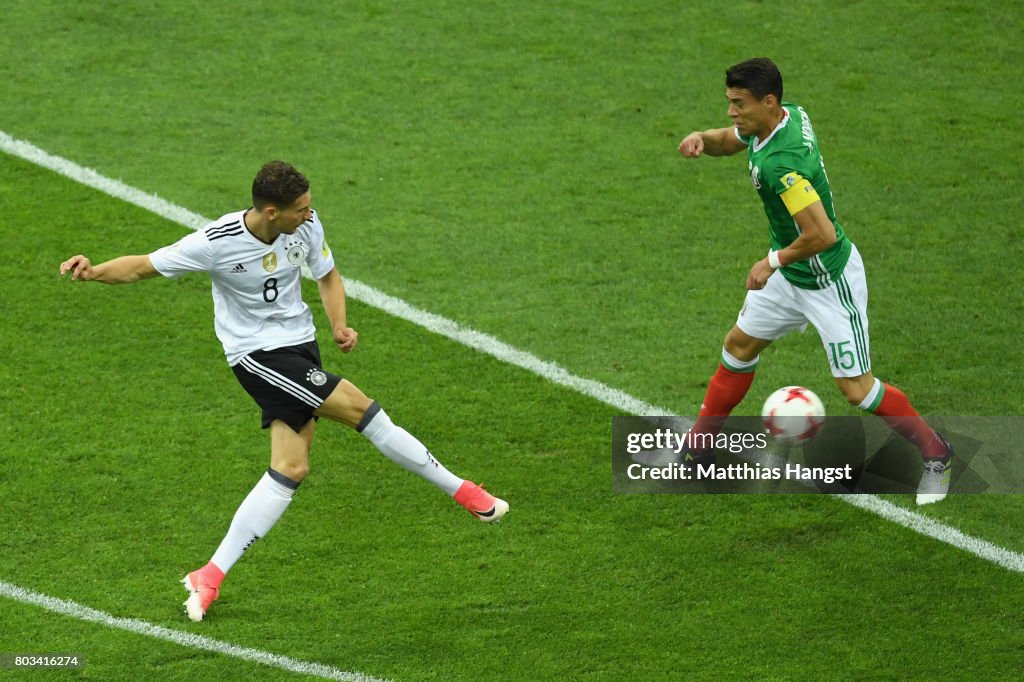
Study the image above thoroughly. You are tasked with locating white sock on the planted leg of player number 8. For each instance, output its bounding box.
[211,469,299,573]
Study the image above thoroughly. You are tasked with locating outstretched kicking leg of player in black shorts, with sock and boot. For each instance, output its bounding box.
[315,380,509,522]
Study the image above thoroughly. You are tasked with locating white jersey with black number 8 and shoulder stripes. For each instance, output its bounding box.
[150,211,334,366]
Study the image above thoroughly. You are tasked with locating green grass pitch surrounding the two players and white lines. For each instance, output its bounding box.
[0,0,1024,682]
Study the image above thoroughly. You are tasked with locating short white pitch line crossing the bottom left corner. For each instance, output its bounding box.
[0,581,388,682]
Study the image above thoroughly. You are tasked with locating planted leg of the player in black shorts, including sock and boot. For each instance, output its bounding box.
[181,419,316,621]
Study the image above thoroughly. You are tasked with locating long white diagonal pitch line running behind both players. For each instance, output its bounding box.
[0,131,1024,572]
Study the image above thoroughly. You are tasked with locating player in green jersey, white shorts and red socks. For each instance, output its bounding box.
[679,57,952,504]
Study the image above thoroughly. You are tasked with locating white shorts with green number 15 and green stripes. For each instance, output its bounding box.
[736,241,871,377]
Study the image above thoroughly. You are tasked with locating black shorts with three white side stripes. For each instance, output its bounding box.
[231,341,341,432]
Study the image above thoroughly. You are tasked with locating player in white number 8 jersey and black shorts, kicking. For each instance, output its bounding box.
[60,161,509,621]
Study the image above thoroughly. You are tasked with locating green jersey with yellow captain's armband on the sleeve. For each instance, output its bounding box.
[736,102,853,289]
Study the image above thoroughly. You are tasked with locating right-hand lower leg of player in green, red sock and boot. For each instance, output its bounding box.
[836,372,953,505]
